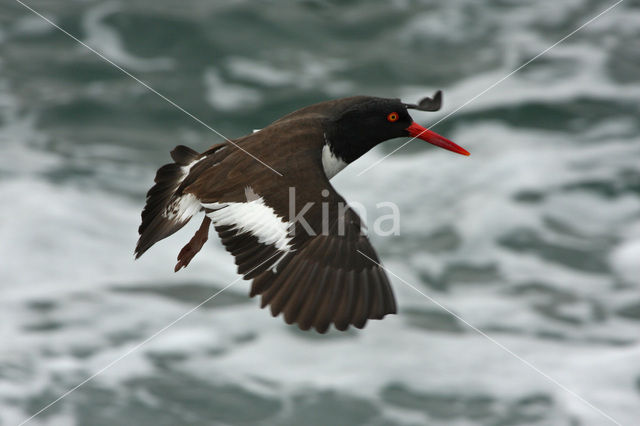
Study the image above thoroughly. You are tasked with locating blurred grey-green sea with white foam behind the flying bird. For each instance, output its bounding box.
[0,0,640,426]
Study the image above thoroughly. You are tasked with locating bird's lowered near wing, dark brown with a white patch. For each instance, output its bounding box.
[190,176,396,333]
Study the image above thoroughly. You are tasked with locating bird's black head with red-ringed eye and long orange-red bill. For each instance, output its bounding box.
[325,91,469,163]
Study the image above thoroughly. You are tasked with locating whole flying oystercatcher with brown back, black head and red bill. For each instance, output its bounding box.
[134,91,469,333]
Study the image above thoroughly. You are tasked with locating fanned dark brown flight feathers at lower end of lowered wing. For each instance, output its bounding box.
[251,206,396,333]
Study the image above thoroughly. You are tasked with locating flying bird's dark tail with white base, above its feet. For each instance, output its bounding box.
[135,145,202,259]
